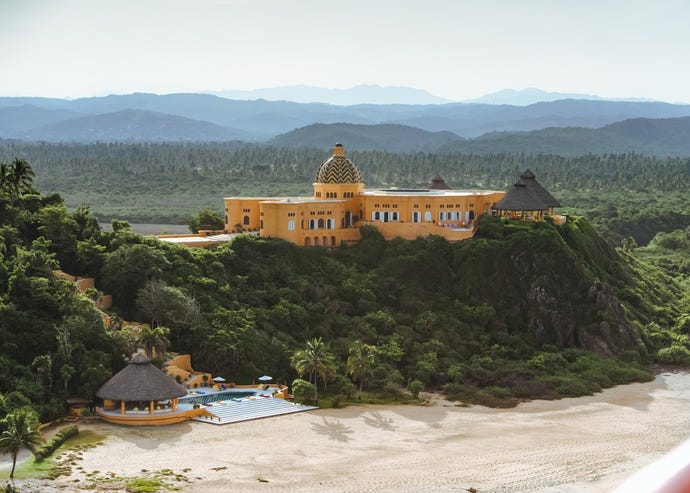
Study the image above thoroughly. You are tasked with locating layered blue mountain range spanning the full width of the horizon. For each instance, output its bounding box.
[0,93,690,154]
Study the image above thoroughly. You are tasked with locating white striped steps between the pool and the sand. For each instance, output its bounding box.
[194,397,317,425]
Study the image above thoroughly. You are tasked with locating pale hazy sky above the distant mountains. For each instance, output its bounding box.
[0,0,690,102]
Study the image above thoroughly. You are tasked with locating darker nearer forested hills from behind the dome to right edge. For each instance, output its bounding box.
[270,117,690,157]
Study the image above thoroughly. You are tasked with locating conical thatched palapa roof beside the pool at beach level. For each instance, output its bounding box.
[96,354,187,401]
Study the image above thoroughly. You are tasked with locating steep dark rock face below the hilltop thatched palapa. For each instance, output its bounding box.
[468,217,646,355]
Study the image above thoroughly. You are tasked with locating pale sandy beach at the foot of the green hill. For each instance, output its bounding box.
[12,373,690,493]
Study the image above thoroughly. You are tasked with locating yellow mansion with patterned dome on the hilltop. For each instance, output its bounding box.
[225,144,505,247]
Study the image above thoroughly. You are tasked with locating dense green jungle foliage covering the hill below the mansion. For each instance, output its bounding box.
[0,157,690,420]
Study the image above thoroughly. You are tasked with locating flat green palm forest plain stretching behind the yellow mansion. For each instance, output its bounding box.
[0,140,690,245]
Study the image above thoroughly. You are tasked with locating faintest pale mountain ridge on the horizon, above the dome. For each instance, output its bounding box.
[209,85,451,106]
